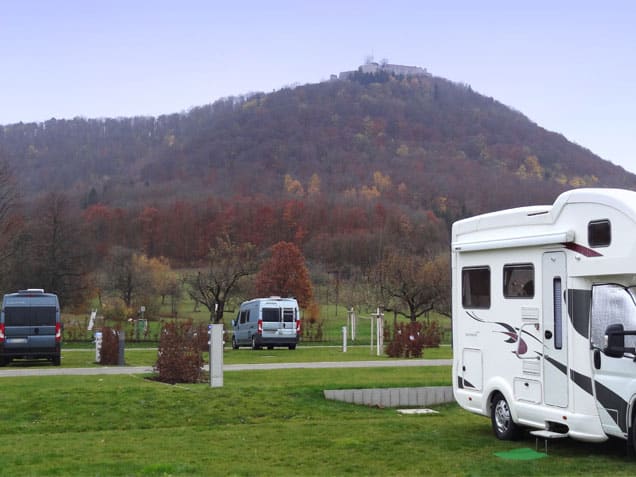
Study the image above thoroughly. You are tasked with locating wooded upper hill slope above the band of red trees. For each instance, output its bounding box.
[0,73,636,215]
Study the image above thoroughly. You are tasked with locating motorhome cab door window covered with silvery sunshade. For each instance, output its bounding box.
[591,284,636,348]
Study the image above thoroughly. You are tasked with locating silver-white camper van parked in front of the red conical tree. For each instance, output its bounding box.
[232,296,300,349]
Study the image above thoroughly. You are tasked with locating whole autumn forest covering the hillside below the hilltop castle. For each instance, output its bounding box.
[0,70,636,314]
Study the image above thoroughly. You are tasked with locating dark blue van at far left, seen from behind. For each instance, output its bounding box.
[0,288,62,366]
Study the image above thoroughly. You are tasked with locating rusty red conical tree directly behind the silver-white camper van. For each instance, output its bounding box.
[256,242,313,308]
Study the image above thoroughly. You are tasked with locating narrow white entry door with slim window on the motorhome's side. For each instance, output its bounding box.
[542,252,568,407]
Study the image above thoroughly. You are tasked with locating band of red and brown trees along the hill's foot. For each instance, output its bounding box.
[0,160,448,322]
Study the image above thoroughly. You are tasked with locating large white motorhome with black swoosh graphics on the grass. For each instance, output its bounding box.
[451,189,636,447]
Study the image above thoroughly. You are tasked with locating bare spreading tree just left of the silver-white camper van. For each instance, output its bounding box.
[185,236,257,323]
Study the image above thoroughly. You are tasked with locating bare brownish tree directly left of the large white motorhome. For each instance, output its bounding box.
[375,251,450,322]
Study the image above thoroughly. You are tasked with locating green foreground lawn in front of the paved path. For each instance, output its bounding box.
[0,367,636,476]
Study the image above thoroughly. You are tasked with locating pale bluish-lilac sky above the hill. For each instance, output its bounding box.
[0,0,636,172]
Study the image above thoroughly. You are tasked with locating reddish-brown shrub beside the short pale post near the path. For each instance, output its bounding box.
[155,321,207,384]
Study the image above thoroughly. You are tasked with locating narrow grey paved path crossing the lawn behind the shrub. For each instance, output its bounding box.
[0,359,453,378]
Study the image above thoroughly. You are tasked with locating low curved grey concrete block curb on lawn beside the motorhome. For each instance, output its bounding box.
[323,386,455,407]
